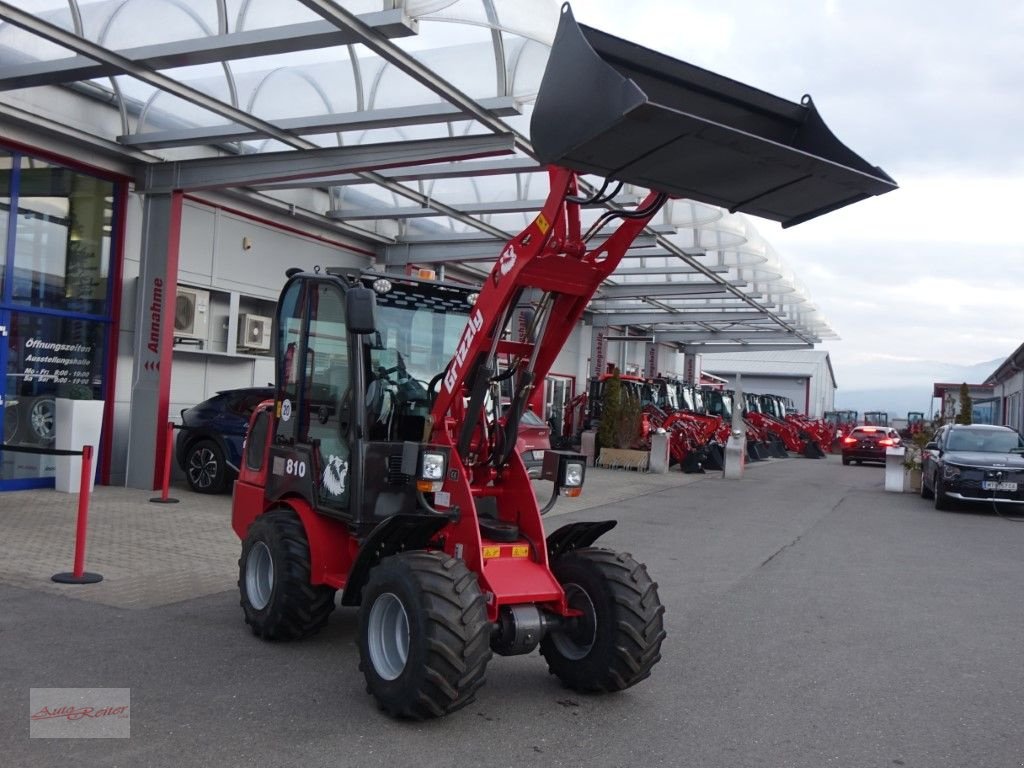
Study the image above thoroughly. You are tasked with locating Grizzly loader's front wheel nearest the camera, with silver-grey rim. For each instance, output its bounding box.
[359,551,490,720]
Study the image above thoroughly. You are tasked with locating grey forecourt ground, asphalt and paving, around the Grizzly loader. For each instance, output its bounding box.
[0,457,1024,768]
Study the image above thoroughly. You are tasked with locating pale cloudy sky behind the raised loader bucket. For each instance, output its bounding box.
[572,0,1024,399]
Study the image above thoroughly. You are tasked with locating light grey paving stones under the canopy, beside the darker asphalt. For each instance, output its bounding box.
[0,467,733,608]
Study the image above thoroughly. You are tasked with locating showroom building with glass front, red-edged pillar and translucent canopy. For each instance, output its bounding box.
[0,0,880,489]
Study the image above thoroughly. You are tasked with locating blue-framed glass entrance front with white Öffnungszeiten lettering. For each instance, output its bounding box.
[0,151,118,490]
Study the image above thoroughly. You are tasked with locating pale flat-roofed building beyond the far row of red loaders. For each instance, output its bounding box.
[702,349,836,419]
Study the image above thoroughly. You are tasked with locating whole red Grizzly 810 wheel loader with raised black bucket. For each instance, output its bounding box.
[232,6,894,718]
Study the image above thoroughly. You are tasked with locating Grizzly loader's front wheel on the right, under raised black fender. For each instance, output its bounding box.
[541,547,665,692]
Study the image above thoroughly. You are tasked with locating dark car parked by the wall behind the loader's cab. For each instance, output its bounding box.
[175,387,273,494]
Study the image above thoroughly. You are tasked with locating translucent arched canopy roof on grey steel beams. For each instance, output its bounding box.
[0,0,835,351]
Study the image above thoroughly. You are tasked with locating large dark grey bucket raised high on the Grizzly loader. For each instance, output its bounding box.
[530,4,896,226]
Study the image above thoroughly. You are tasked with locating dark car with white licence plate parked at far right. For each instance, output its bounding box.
[921,424,1024,509]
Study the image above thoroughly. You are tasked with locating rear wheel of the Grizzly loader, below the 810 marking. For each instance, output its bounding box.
[239,509,335,640]
